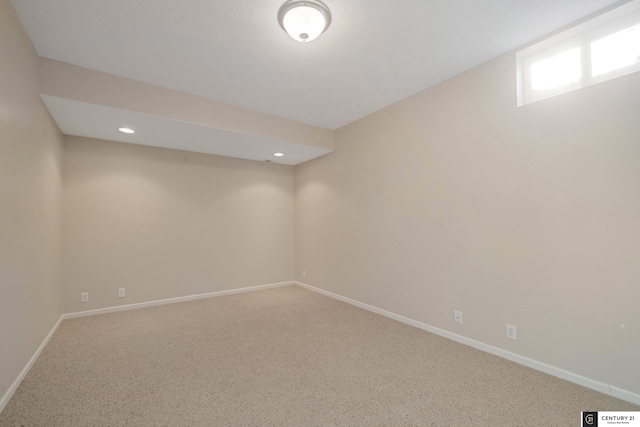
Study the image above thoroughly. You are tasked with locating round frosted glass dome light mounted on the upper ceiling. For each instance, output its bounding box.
[278,0,331,42]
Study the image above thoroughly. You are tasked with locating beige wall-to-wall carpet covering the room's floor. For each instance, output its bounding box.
[0,286,640,427]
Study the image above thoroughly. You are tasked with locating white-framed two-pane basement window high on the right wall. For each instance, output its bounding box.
[516,0,640,107]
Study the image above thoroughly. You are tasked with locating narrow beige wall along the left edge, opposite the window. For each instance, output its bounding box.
[0,0,62,399]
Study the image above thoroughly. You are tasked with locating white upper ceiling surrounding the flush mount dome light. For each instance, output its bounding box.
[7,0,624,164]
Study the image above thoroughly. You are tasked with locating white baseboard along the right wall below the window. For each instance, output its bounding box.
[295,281,640,405]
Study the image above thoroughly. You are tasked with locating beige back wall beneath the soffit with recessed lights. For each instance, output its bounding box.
[63,137,294,313]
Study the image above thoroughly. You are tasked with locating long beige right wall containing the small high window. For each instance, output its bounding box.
[295,53,640,393]
